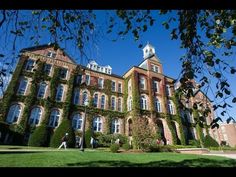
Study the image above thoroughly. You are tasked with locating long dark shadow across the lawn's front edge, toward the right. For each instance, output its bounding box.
[66,158,236,167]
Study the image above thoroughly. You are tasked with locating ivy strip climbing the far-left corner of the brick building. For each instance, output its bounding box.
[0,57,26,121]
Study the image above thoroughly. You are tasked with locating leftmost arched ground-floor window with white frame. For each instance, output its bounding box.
[6,104,21,123]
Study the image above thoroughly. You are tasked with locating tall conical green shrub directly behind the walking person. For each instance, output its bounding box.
[50,119,75,147]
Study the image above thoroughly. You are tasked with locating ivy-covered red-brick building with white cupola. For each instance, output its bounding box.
[1,44,219,147]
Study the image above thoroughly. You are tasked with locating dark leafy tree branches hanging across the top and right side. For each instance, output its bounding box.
[0,10,236,128]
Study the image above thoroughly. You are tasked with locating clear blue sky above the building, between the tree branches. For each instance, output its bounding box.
[0,11,236,121]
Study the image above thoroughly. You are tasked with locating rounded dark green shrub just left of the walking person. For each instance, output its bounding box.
[29,125,48,147]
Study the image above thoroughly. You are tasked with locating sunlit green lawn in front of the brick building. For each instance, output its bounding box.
[0,146,236,167]
